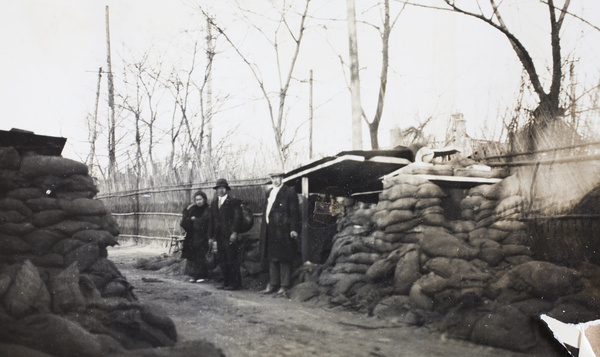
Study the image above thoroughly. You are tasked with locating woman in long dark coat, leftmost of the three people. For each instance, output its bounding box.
[180,191,209,283]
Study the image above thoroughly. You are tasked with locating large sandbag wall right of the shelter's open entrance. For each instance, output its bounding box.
[319,166,600,351]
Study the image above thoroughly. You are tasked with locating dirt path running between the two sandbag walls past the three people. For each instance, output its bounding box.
[109,245,540,357]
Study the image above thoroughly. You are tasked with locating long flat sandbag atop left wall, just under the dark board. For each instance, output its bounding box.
[20,155,88,177]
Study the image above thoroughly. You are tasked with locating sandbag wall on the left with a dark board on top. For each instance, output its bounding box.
[0,148,177,356]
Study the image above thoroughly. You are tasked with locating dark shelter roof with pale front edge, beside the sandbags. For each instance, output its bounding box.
[284,148,413,196]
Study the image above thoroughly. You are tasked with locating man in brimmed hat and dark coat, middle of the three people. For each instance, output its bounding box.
[209,178,242,290]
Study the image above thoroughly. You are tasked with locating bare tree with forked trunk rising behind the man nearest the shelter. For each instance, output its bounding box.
[200,0,310,168]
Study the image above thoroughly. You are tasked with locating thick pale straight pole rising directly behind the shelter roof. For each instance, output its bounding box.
[346,0,362,150]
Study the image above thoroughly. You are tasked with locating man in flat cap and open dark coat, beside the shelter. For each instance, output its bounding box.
[260,173,301,296]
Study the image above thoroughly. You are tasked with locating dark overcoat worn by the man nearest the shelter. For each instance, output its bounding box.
[260,185,302,263]
